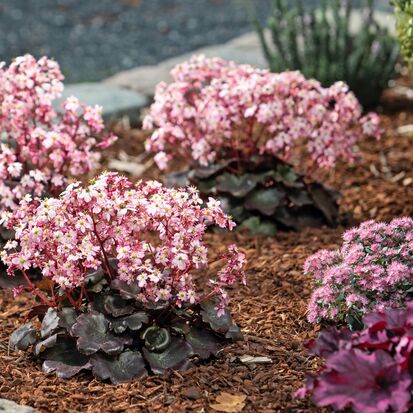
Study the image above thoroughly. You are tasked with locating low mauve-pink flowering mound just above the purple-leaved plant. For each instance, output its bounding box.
[304,217,413,323]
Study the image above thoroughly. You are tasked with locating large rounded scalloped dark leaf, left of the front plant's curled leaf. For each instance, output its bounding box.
[71,311,132,355]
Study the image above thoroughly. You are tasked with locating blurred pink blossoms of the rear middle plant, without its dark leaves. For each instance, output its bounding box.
[143,55,381,169]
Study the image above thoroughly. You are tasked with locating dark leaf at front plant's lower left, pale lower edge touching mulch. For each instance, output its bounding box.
[41,336,91,379]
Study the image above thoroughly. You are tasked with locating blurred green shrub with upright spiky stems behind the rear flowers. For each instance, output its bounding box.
[254,0,399,107]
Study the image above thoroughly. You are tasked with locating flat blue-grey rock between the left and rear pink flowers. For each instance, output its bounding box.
[56,82,148,120]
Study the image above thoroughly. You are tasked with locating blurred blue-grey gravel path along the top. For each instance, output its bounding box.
[0,0,387,82]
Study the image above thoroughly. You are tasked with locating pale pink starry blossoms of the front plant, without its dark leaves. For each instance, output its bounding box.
[2,173,245,310]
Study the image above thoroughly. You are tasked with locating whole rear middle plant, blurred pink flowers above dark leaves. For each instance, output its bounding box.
[143,56,380,233]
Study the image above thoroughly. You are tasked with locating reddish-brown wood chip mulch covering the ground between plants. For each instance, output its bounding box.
[0,96,413,413]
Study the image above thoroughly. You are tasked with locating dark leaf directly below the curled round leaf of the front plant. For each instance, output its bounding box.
[143,337,193,374]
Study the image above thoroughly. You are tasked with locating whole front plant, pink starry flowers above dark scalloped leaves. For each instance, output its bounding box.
[2,173,245,383]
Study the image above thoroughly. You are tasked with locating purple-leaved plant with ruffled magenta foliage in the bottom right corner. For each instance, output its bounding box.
[296,302,413,413]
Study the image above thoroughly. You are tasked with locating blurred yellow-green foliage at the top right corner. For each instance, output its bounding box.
[392,0,413,66]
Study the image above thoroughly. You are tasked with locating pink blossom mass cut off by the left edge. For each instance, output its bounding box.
[0,55,115,212]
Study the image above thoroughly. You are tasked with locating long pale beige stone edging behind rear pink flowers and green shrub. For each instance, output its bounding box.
[104,11,395,96]
